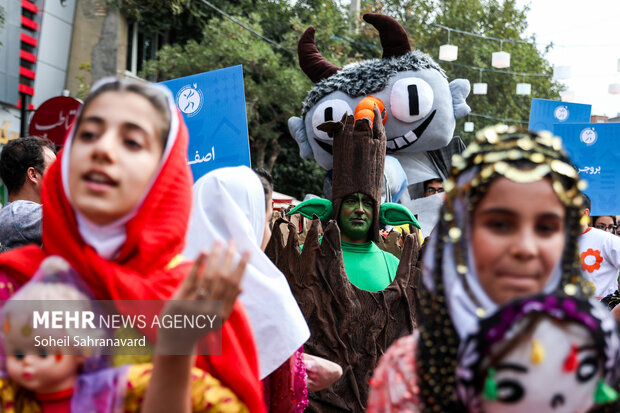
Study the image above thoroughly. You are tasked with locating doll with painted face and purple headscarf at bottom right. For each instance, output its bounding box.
[456,294,620,413]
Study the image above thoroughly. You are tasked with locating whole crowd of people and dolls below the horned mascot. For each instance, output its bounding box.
[0,43,620,413]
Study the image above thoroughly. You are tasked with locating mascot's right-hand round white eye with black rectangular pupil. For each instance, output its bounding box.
[390,77,435,123]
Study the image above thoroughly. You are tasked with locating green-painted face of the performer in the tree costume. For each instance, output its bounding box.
[338,192,374,244]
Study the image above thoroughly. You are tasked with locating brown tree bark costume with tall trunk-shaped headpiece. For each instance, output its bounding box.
[266,112,420,412]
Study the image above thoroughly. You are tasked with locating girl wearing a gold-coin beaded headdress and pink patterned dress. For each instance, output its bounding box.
[368,126,590,412]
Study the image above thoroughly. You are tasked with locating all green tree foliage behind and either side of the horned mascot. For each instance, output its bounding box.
[127,0,561,198]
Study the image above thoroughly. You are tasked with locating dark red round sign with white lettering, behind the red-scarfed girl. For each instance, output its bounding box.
[28,96,82,145]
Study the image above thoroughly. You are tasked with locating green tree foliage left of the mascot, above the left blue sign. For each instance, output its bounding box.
[139,1,349,197]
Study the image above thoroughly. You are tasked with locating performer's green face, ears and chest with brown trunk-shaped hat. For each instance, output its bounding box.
[288,106,419,292]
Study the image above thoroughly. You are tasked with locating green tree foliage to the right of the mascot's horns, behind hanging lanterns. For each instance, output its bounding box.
[358,0,563,142]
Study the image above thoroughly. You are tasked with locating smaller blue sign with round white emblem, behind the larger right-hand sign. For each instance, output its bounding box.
[529,99,592,132]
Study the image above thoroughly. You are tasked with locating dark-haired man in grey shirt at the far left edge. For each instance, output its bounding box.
[0,136,56,250]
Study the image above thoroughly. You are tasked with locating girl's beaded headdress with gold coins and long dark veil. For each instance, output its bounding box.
[416,125,589,412]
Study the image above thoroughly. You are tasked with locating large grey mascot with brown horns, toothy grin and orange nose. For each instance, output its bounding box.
[288,14,470,202]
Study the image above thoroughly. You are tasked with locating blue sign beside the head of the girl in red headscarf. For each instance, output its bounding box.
[162,66,251,182]
